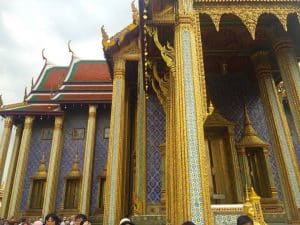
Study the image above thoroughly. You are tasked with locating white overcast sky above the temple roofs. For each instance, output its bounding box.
[0,0,137,184]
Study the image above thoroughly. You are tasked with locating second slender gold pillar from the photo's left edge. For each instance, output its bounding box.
[0,125,22,218]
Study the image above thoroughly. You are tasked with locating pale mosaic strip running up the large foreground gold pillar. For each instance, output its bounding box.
[181,30,205,225]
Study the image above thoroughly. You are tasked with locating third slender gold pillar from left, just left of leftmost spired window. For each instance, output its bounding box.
[8,116,34,218]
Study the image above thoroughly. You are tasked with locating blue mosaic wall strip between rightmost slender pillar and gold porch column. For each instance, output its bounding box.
[91,105,110,212]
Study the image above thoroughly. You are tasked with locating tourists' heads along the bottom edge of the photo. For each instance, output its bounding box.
[0,213,253,225]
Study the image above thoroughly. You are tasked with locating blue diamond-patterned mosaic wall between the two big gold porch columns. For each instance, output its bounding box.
[147,94,165,203]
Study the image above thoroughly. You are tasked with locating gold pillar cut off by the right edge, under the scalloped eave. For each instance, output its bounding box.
[273,38,300,143]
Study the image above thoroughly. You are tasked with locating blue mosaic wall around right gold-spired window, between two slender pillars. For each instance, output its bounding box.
[56,108,88,210]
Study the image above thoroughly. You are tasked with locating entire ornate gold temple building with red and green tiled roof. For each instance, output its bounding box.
[0,0,300,225]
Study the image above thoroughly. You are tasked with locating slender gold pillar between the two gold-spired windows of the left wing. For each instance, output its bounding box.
[42,116,63,216]
